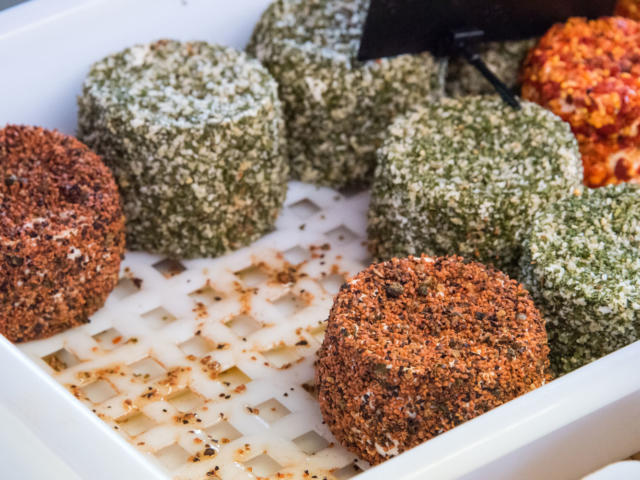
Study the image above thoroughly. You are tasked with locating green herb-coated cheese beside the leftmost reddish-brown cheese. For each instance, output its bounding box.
[78,40,288,257]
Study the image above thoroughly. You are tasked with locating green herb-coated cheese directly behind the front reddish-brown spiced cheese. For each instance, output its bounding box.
[368,97,582,273]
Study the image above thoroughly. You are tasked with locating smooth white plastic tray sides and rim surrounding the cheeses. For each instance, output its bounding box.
[0,0,640,480]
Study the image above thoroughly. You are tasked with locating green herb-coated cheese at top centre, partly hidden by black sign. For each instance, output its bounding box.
[247,0,438,187]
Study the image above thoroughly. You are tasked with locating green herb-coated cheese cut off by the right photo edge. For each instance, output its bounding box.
[522,185,640,373]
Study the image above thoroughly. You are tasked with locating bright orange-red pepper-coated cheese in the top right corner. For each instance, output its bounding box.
[522,17,640,187]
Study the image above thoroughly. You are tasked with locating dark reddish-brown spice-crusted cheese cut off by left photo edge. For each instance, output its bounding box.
[0,125,124,342]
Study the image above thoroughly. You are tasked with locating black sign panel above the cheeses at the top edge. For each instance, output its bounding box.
[358,0,616,60]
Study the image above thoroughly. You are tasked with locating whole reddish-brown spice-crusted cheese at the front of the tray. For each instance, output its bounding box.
[316,256,549,464]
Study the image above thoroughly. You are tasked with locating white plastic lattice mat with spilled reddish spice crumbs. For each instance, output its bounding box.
[21,182,368,480]
